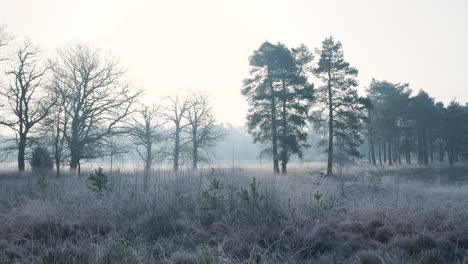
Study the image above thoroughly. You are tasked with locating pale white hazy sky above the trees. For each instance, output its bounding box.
[0,0,468,125]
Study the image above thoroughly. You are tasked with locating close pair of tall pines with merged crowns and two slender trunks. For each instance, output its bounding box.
[242,42,313,174]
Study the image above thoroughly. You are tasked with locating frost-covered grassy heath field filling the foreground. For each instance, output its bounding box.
[0,165,468,264]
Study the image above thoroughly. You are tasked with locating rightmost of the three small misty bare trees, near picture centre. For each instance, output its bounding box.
[186,91,224,170]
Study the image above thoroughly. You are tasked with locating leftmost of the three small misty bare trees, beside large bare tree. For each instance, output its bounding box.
[130,105,165,192]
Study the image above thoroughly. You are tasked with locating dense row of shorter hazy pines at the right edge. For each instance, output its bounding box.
[367,80,468,166]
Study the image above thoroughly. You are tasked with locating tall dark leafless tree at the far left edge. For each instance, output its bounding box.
[0,41,54,171]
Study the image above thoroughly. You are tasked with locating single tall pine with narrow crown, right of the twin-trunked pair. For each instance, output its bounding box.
[312,37,366,175]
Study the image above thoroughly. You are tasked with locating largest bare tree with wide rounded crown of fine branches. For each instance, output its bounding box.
[53,44,142,174]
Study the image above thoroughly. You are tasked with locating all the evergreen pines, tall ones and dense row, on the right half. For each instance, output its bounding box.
[241,37,468,175]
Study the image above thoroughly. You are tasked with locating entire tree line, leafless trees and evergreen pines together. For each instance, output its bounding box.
[0,27,468,179]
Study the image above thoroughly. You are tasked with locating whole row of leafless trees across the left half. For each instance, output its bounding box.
[0,27,223,175]
